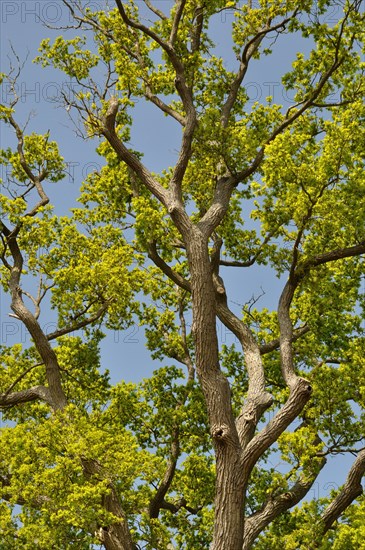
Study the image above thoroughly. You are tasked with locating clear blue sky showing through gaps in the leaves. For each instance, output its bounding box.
[0,0,351,497]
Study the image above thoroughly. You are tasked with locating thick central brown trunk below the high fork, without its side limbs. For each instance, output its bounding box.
[186,227,245,550]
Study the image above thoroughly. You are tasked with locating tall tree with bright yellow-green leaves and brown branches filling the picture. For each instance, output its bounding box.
[0,0,365,550]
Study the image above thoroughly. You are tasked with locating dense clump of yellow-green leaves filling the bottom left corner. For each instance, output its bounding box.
[0,406,153,548]
